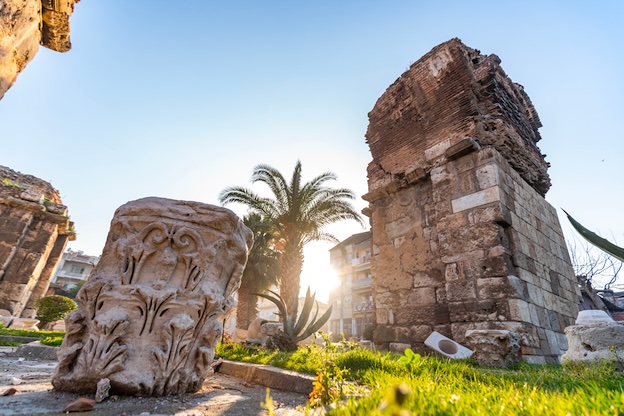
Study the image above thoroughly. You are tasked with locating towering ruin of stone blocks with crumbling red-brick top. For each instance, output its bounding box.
[364,39,579,362]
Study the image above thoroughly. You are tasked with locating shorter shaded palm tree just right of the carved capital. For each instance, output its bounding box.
[236,213,279,330]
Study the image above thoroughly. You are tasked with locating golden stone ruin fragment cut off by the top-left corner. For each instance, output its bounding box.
[0,0,78,99]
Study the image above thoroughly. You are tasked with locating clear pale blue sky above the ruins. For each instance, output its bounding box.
[0,0,624,298]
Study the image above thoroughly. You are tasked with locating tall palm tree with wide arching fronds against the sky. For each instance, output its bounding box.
[219,161,363,315]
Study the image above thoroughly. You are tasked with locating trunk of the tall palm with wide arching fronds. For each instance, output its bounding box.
[280,241,303,319]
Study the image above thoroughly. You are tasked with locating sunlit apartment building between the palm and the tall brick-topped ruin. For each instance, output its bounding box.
[329,231,373,339]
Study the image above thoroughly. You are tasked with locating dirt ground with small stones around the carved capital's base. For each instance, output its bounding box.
[0,347,307,416]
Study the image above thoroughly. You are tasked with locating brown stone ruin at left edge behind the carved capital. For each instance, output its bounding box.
[0,166,76,318]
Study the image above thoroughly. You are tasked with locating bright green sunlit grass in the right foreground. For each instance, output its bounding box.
[217,344,624,415]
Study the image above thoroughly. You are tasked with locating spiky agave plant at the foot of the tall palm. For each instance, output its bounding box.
[256,287,333,351]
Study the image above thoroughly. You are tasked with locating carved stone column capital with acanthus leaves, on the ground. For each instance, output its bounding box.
[52,198,253,396]
